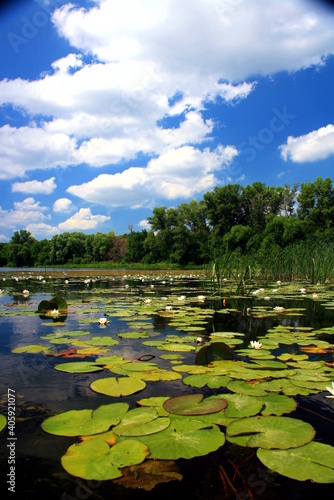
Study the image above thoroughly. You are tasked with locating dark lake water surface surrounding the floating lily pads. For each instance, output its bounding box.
[0,270,334,500]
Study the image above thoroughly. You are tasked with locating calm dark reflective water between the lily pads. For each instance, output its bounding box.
[0,270,334,500]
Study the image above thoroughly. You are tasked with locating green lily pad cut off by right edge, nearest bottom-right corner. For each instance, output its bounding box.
[257,441,334,483]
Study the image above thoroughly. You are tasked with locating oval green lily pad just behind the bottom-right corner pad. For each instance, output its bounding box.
[226,416,315,450]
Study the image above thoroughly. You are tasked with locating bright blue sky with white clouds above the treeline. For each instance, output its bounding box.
[0,0,334,242]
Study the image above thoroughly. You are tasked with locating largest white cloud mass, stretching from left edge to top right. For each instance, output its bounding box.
[0,0,334,183]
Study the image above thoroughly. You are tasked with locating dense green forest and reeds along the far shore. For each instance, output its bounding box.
[0,177,334,282]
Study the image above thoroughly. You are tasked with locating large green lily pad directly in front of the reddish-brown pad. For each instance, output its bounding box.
[132,417,225,460]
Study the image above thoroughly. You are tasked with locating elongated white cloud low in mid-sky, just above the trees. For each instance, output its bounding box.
[67,146,238,207]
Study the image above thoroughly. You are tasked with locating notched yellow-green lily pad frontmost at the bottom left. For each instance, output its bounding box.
[61,439,150,481]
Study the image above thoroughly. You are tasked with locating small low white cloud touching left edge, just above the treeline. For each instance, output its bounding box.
[0,197,50,230]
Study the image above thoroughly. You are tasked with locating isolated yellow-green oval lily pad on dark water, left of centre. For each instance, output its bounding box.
[90,377,146,398]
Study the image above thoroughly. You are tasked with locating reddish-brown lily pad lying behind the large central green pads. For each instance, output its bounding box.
[163,394,227,415]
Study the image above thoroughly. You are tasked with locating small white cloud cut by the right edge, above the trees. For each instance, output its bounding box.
[279,124,334,163]
